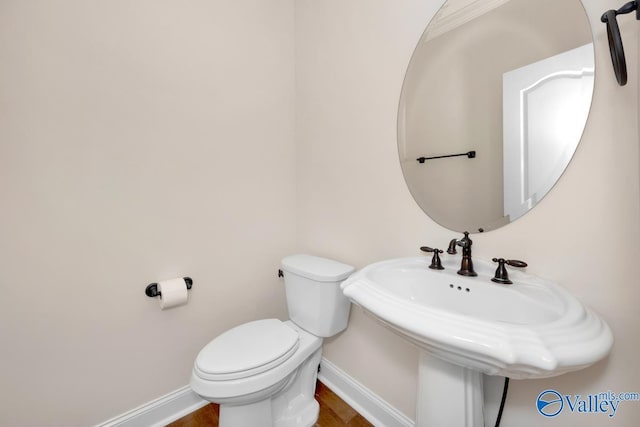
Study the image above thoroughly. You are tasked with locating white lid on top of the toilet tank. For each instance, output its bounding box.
[282,254,355,282]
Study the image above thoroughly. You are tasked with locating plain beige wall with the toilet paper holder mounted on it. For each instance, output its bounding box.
[0,0,296,426]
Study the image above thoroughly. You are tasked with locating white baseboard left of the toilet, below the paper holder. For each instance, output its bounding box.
[96,385,209,427]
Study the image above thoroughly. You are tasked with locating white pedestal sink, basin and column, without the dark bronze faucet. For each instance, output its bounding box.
[342,257,613,427]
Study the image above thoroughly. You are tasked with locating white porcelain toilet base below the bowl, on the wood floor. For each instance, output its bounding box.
[219,348,322,427]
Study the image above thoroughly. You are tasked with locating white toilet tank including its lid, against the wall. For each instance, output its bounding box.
[282,255,355,337]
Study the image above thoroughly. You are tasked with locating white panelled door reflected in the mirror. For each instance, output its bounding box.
[502,43,594,221]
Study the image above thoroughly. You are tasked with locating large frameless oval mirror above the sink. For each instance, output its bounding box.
[398,0,594,232]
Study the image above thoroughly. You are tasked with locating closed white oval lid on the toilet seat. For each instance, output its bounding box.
[196,319,298,380]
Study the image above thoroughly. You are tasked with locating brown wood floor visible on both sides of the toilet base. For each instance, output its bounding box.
[167,381,373,427]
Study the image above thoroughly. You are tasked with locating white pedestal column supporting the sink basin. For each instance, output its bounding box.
[416,350,484,427]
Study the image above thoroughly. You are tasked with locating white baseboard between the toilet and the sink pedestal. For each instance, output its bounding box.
[318,357,415,427]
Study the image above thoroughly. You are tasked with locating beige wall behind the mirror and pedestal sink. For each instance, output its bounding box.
[296,0,640,427]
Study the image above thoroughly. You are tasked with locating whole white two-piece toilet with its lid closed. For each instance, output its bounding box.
[191,255,354,427]
